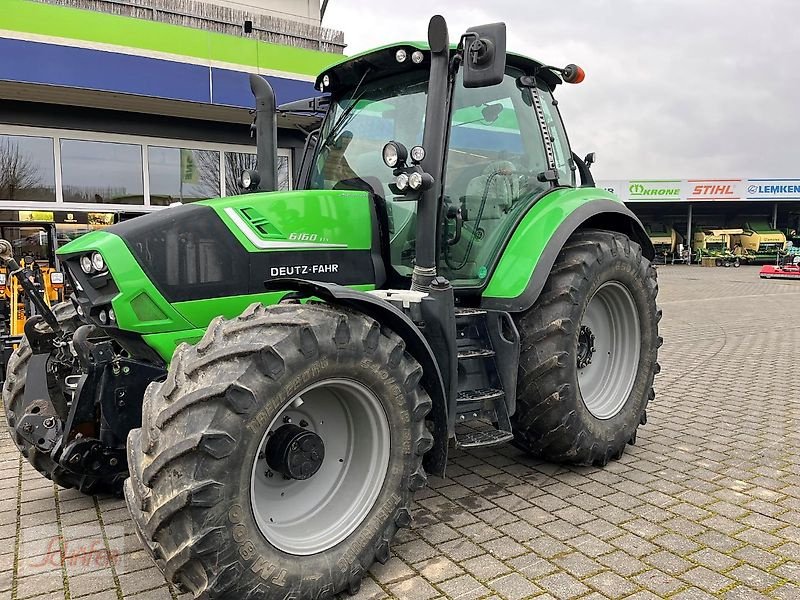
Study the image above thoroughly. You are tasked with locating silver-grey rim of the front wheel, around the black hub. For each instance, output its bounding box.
[250,379,390,556]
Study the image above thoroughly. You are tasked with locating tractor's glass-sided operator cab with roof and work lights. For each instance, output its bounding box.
[299,38,578,289]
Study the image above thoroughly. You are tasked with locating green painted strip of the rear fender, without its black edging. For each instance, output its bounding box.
[483,188,622,298]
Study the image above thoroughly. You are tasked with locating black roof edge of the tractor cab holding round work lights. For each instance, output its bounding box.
[314,42,561,95]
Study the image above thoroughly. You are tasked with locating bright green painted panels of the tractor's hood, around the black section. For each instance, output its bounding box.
[58,190,374,362]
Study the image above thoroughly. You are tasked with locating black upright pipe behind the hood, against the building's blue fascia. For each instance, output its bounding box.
[250,75,278,192]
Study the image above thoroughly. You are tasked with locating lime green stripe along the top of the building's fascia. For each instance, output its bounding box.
[0,0,342,75]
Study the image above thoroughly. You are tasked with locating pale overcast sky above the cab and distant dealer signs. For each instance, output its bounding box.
[323,0,800,179]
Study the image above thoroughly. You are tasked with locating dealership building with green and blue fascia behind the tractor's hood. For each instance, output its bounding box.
[0,0,344,237]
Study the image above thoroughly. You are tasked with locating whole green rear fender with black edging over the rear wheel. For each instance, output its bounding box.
[481,188,655,312]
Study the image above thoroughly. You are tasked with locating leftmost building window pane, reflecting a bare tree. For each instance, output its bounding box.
[0,135,56,202]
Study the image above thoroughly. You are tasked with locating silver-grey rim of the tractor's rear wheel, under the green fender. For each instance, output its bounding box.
[577,281,642,419]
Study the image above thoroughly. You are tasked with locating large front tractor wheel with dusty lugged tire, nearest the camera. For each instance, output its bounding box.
[125,304,433,600]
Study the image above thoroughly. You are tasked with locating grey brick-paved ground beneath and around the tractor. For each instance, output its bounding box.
[0,266,800,600]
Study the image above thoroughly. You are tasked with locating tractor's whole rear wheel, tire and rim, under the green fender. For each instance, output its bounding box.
[513,230,661,465]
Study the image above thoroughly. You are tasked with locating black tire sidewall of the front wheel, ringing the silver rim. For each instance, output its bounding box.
[163,315,430,598]
